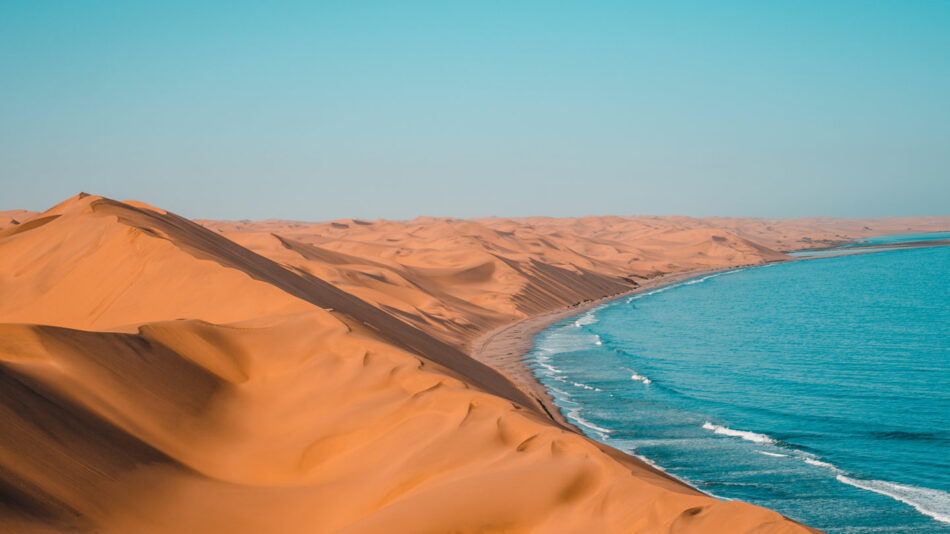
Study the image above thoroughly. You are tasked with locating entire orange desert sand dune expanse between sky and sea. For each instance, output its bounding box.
[0,194,950,534]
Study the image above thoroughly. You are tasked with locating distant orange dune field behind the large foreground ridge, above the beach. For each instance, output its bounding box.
[207,218,784,347]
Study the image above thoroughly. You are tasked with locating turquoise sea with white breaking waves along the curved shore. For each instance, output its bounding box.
[529,241,950,533]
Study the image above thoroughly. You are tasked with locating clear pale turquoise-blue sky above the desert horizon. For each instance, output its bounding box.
[0,0,950,220]
